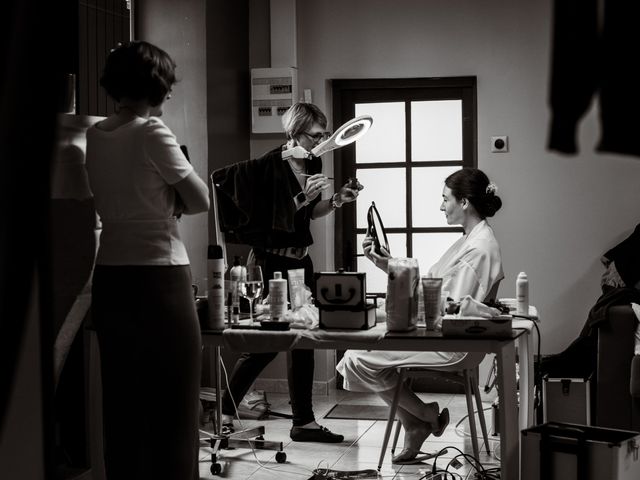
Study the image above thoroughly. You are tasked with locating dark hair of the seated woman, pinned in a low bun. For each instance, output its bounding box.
[444,168,502,218]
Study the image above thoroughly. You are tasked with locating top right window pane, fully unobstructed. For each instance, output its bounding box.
[412,100,462,162]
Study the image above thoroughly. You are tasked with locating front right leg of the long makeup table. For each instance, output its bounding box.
[496,342,520,480]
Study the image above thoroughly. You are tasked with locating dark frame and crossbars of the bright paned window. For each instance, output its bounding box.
[331,76,478,271]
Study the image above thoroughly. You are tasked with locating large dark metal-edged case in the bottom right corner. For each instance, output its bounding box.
[520,422,640,480]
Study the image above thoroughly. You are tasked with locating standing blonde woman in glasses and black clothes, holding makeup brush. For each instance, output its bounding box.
[213,103,358,443]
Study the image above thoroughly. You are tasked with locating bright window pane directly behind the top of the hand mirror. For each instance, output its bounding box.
[356,168,404,228]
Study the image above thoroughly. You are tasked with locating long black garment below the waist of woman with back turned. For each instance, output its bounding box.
[92,265,202,480]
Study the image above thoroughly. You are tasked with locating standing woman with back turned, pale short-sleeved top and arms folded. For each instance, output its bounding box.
[87,42,209,480]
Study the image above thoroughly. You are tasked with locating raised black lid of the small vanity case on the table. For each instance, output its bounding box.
[314,269,367,312]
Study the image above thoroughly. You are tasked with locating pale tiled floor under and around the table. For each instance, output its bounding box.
[200,391,499,480]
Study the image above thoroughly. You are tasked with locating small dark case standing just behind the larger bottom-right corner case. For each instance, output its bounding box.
[542,375,591,425]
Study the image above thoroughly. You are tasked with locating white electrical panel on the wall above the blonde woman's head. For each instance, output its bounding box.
[251,67,298,133]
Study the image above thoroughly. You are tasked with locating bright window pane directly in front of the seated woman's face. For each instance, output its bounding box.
[412,167,460,227]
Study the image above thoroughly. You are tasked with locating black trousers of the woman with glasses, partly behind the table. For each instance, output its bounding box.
[222,249,315,426]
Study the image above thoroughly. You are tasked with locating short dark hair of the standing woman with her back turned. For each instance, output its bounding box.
[100,41,176,107]
